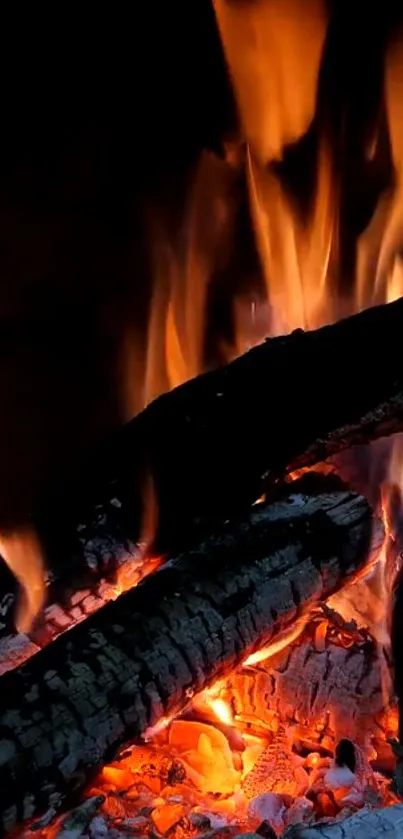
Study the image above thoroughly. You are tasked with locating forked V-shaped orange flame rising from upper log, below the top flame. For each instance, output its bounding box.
[247,139,342,335]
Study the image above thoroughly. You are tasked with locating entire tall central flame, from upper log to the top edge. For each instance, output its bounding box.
[214,0,340,334]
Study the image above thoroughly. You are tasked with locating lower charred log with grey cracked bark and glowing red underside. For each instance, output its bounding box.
[0,481,372,831]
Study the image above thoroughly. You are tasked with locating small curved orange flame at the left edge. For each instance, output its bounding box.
[0,527,45,632]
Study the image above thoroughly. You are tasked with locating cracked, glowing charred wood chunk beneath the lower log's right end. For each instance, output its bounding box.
[221,608,392,768]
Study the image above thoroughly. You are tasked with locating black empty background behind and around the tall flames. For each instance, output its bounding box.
[0,0,397,528]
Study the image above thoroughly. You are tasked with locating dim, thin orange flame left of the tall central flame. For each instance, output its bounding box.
[139,152,240,414]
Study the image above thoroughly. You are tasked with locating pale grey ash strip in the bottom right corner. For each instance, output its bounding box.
[282,804,403,839]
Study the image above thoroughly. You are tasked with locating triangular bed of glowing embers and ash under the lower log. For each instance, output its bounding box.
[14,607,403,839]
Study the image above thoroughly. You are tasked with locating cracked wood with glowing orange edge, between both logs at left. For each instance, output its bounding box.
[0,496,153,644]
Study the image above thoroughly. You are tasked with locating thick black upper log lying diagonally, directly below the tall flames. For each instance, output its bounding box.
[32,300,403,567]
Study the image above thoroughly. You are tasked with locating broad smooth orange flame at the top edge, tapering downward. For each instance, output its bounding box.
[213,0,327,164]
